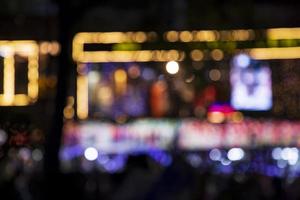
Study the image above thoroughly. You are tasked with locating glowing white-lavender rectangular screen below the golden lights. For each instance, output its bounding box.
[230,54,272,111]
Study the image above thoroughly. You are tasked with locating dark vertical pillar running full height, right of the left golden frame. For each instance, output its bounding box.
[41,0,72,199]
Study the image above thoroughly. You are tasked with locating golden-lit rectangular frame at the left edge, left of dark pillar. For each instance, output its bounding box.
[0,40,39,106]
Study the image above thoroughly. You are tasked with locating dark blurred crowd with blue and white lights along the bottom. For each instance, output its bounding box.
[0,119,300,200]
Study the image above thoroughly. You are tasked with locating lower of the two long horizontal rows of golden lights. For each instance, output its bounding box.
[73,47,300,63]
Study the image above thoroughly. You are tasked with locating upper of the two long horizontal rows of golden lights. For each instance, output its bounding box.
[74,28,300,44]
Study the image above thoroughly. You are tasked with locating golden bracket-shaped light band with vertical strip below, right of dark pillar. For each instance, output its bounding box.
[72,32,185,119]
